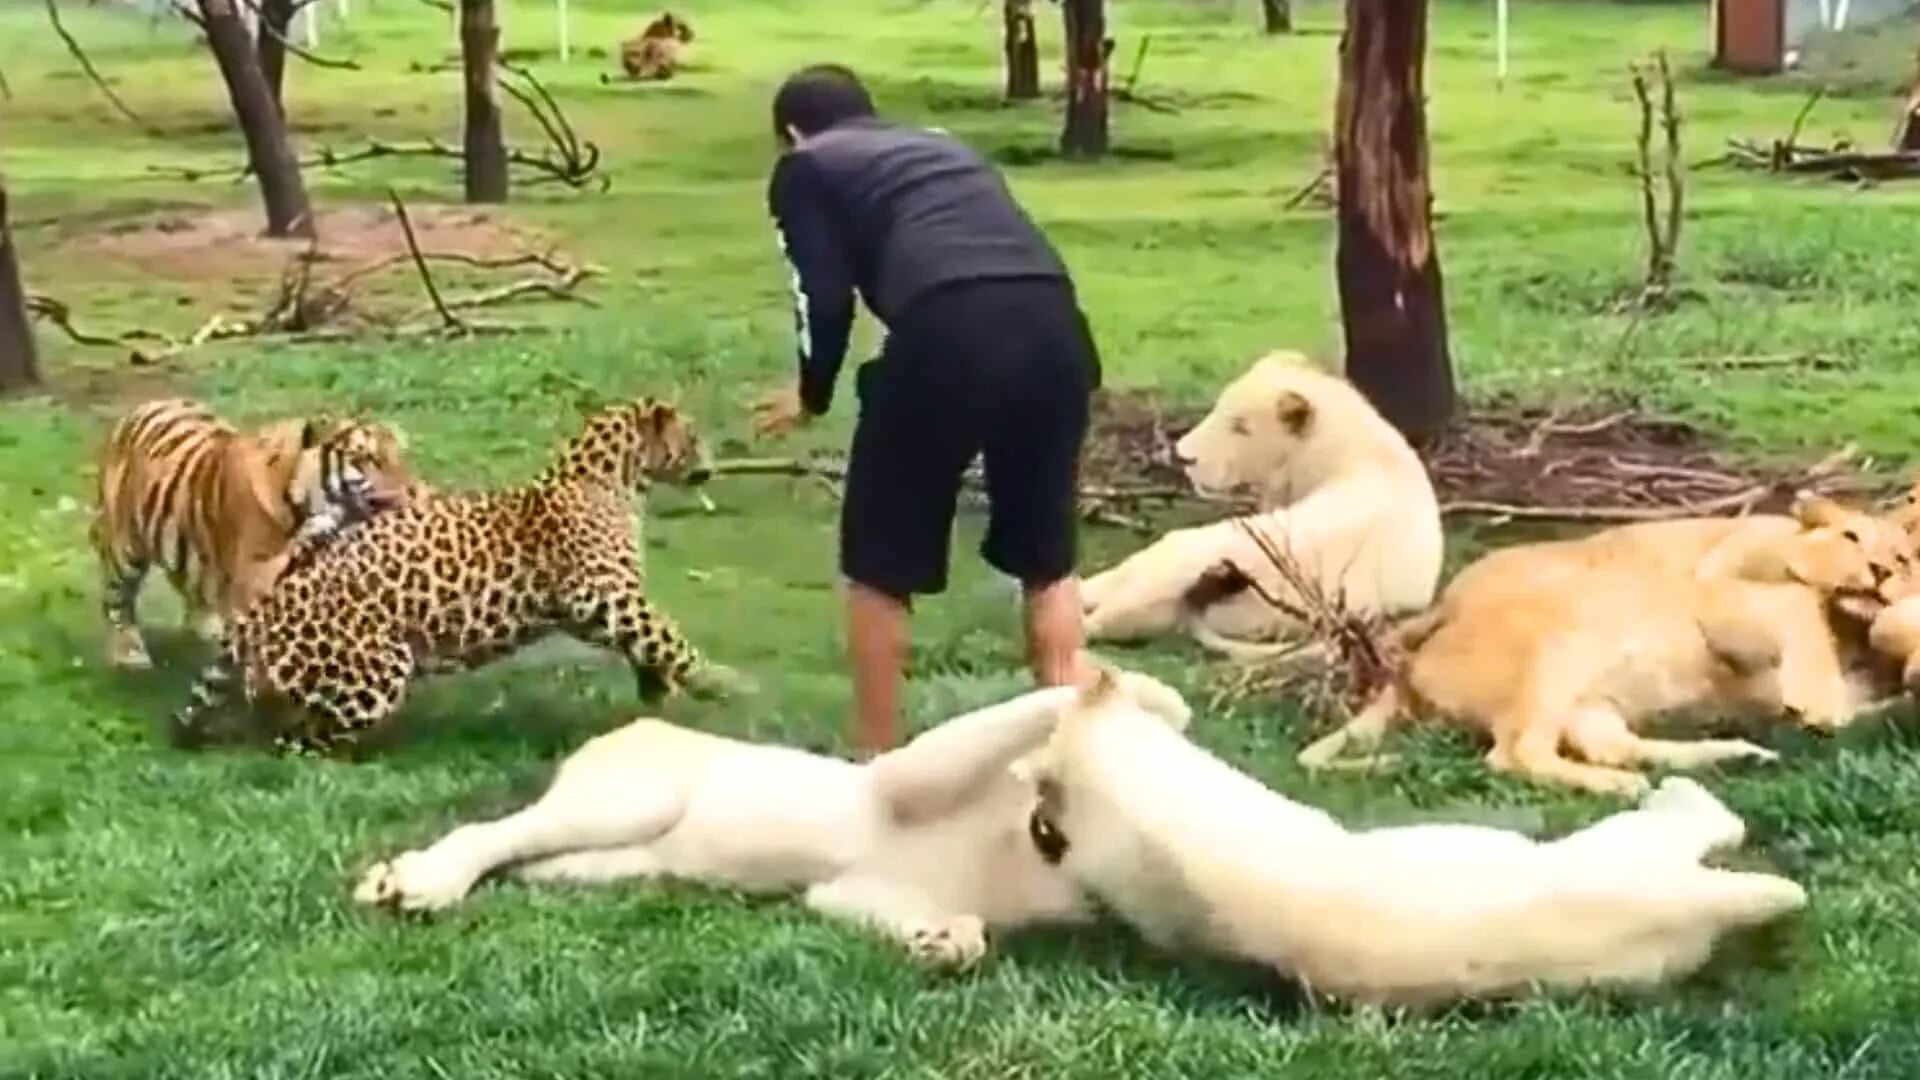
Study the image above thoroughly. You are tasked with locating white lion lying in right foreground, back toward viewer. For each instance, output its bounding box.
[1029,668,1807,1005]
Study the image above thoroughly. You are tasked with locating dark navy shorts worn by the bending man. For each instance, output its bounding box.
[841,279,1100,600]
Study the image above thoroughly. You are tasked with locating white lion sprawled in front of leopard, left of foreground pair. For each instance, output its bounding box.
[353,673,1190,965]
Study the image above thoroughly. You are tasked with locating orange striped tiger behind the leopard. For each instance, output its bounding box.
[88,398,426,669]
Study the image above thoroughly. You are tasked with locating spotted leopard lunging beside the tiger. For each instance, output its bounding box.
[169,398,743,757]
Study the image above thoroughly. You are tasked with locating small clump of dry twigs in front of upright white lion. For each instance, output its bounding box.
[1187,521,1402,717]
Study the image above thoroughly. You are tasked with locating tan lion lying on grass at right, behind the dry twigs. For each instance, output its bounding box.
[1300,496,1901,796]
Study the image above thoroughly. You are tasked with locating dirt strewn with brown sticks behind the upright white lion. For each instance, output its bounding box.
[1083,390,1880,521]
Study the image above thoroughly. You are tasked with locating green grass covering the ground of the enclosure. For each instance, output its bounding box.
[0,0,1920,1080]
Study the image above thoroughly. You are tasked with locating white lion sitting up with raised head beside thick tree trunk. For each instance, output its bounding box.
[1081,352,1444,655]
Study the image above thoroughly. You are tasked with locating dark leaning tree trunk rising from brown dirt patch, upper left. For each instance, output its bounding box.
[200,0,313,236]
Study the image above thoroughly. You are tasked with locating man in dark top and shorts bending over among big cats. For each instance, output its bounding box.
[756,65,1100,753]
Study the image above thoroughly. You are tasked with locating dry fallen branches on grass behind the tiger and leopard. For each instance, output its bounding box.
[27,192,599,365]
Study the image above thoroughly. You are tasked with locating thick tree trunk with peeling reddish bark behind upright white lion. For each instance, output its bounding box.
[1334,0,1453,444]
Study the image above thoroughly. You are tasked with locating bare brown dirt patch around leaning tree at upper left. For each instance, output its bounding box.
[63,206,541,281]
